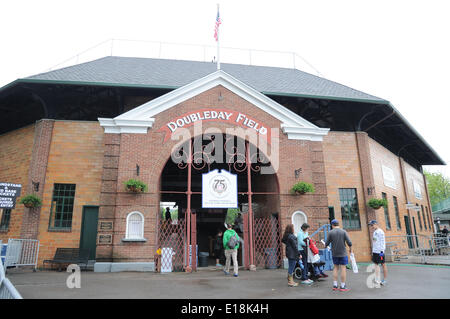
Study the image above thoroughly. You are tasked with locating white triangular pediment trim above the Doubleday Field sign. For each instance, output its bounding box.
[99,70,329,141]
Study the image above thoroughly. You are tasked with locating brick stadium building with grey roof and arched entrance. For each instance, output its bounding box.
[0,57,444,270]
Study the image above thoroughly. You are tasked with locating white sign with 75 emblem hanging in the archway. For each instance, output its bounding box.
[202,169,238,208]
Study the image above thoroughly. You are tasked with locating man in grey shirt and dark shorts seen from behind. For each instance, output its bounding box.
[325,219,352,291]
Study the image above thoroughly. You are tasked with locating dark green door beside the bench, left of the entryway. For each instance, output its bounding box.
[80,206,98,260]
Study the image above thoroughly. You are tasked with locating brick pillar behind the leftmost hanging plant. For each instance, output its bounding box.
[20,120,55,239]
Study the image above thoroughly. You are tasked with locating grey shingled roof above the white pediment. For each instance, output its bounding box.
[18,56,387,103]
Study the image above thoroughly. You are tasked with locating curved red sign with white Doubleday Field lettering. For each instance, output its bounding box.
[159,109,270,143]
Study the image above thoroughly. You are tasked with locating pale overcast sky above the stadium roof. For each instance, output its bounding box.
[0,0,450,177]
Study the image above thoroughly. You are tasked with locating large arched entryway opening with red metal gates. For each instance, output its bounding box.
[157,133,281,271]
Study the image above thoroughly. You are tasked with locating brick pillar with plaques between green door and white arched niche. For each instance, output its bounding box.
[96,134,120,262]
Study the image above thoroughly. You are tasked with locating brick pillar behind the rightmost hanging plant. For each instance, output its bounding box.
[355,132,377,253]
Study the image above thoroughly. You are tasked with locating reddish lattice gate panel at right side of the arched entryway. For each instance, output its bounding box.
[253,217,281,269]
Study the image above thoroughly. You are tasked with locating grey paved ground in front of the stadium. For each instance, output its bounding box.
[8,265,450,299]
